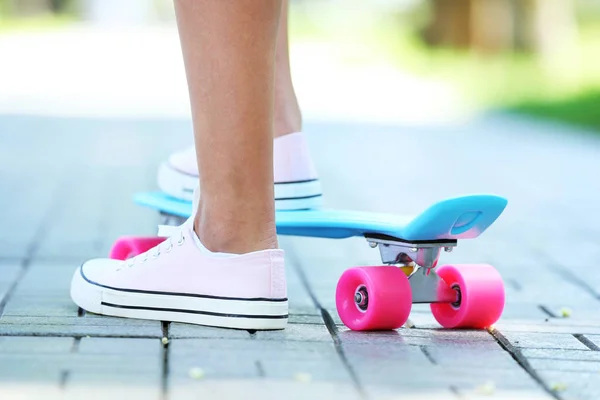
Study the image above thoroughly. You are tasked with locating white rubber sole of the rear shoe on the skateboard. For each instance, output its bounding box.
[158,162,322,210]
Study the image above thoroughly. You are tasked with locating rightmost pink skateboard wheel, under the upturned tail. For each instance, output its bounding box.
[431,264,504,329]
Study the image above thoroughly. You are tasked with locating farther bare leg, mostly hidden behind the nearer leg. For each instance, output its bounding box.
[273,0,302,137]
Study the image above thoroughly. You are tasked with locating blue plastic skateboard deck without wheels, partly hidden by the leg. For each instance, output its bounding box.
[134,192,507,242]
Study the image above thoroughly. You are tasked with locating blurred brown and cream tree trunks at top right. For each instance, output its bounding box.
[423,0,577,54]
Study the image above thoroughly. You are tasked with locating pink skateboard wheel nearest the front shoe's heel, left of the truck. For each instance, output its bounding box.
[335,266,412,331]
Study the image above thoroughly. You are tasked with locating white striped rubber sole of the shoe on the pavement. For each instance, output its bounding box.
[71,267,288,330]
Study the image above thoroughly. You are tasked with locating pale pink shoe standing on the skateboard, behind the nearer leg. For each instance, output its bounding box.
[158,132,321,210]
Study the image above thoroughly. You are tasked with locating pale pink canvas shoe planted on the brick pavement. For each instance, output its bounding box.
[71,218,288,330]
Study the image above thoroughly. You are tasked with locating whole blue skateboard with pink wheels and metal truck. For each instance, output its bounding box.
[111,192,507,331]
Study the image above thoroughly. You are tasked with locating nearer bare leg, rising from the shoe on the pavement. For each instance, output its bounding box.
[175,0,281,253]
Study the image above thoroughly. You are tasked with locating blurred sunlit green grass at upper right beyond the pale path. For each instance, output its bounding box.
[290,2,600,132]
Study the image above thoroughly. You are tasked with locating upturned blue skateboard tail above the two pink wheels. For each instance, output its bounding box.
[402,194,508,240]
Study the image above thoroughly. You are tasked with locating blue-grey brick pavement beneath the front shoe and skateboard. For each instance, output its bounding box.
[0,116,600,400]
